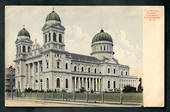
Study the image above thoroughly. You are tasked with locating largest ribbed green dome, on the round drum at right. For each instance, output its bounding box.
[92,29,113,43]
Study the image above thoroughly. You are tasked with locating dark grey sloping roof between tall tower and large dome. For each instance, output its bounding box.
[70,53,100,62]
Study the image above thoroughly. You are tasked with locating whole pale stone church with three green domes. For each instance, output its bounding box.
[14,10,138,92]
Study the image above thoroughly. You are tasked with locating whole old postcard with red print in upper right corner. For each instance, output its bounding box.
[5,6,164,107]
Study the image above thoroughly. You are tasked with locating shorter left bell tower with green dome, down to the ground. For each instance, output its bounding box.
[15,27,33,91]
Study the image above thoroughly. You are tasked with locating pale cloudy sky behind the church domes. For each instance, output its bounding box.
[5,6,143,77]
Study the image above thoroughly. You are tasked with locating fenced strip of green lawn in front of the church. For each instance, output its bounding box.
[6,92,143,104]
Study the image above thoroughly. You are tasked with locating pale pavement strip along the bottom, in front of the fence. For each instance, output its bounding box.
[5,98,141,107]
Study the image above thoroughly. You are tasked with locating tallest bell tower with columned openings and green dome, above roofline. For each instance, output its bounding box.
[42,10,65,51]
